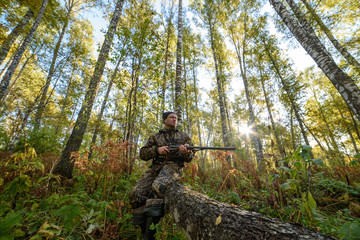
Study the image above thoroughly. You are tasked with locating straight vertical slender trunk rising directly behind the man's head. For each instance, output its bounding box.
[175,0,183,126]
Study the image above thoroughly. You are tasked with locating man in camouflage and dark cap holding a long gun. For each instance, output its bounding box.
[130,112,194,239]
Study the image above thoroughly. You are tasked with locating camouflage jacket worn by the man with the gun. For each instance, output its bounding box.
[140,128,194,168]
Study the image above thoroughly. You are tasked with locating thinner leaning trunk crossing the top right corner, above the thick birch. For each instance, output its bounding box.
[301,0,360,73]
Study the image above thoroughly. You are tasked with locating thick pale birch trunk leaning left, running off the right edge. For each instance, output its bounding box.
[269,0,360,120]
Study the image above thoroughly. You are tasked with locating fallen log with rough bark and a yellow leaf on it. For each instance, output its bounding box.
[164,183,334,240]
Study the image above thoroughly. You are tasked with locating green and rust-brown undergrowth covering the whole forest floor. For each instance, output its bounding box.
[0,145,360,240]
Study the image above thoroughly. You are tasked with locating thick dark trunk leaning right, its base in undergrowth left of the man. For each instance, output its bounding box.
[54,0,125,178]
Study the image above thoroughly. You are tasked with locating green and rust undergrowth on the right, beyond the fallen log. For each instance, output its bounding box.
[181,146,360,239]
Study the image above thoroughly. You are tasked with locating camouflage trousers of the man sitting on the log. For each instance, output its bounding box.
[129,163,182,209]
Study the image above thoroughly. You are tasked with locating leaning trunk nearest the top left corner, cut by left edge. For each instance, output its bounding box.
[0,8,34,65]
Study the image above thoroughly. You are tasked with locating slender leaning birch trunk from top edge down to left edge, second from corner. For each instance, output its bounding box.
[0,0,49,102]
